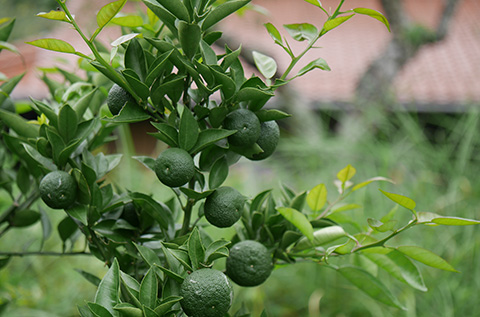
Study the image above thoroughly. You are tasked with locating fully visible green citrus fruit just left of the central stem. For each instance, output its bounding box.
[154,148,195,187]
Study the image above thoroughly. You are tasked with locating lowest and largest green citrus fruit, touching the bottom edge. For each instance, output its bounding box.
[180,269,233,317]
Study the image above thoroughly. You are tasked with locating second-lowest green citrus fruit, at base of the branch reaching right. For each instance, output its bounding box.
[226,240,273,286]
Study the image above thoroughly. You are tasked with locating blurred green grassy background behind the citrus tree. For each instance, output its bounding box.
[0,0,480,317]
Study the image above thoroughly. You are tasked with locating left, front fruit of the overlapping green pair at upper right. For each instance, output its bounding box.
[223,109,260,146]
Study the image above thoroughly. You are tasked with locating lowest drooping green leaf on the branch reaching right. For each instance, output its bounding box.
[337,266,405,310]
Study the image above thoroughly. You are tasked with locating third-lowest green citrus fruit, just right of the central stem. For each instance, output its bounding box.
[204,186,245,228]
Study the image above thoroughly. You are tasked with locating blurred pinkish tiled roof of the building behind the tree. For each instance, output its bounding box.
[0,0,480,111]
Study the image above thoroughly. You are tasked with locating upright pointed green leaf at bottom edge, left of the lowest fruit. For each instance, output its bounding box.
[95,259,120,316]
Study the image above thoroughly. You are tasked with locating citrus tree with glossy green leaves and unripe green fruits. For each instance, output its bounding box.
[0,0,479,317]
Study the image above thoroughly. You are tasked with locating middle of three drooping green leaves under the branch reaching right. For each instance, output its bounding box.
[363,248,428,292]
